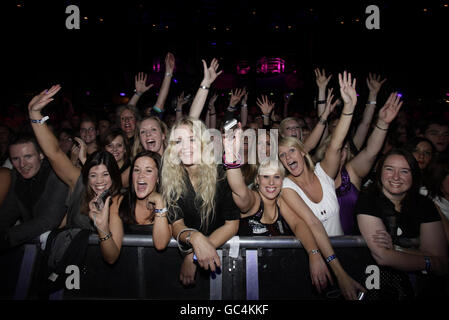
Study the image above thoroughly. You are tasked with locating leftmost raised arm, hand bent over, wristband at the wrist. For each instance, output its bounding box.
[28,85,81,189]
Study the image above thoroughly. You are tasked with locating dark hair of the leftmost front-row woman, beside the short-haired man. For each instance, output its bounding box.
[81,151,122,214]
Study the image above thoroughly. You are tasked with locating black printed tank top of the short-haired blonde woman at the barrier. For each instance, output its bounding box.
[238,199,294,237]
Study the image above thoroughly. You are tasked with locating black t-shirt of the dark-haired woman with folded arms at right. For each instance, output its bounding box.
[355,192,441,240]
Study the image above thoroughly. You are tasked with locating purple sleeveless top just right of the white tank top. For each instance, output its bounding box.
[335,167,359,235]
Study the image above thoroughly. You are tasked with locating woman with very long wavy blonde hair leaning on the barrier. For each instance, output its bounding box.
[162,118,240,285]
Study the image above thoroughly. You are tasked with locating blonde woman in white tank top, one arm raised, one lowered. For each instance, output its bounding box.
[279,72,364,299]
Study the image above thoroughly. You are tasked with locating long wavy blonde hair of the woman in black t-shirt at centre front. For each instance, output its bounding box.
[162,118,219,230]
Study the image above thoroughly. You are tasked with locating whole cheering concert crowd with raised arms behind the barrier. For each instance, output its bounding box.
[0,53,449,299]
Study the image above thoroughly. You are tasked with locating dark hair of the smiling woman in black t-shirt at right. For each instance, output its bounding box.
[375,148,422,211]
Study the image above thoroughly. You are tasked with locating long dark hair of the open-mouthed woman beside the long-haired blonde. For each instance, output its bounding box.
[119,150,162,224]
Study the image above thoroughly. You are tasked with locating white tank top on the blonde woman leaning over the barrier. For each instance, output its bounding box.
[282,162,343,237]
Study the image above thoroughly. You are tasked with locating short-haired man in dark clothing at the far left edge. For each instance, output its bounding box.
[0,135,69,250]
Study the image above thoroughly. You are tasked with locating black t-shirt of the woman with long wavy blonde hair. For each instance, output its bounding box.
[170,166,240,236]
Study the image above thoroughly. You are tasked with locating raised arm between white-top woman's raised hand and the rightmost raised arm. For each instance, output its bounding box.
[352,72,387,150]
